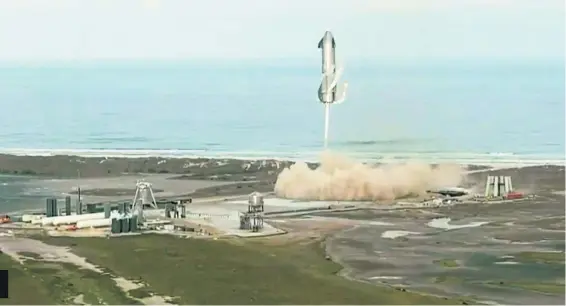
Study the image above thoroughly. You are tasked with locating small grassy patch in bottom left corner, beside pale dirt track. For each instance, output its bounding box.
[0,254,139,305]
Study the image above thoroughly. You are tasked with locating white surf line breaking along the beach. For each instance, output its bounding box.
[0,148,565,167]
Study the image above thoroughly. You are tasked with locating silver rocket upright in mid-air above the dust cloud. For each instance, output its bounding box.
[318,31,348,104]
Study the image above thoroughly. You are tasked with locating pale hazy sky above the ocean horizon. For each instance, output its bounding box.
[0,0,565,61]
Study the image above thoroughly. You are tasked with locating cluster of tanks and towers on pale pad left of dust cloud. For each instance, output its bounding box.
[11,181,288,237]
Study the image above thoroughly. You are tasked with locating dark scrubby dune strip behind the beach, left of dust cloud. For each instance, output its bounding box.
[0,154,491,181]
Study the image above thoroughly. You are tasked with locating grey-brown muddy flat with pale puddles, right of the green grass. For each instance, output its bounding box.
[327,167,565,305]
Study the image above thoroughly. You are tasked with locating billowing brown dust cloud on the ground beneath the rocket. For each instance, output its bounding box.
[275,151,464,201]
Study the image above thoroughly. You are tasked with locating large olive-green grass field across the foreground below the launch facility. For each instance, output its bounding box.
[12,235,472,304]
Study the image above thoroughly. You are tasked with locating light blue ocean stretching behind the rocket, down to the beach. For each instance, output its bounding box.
[0,60,565,164]
